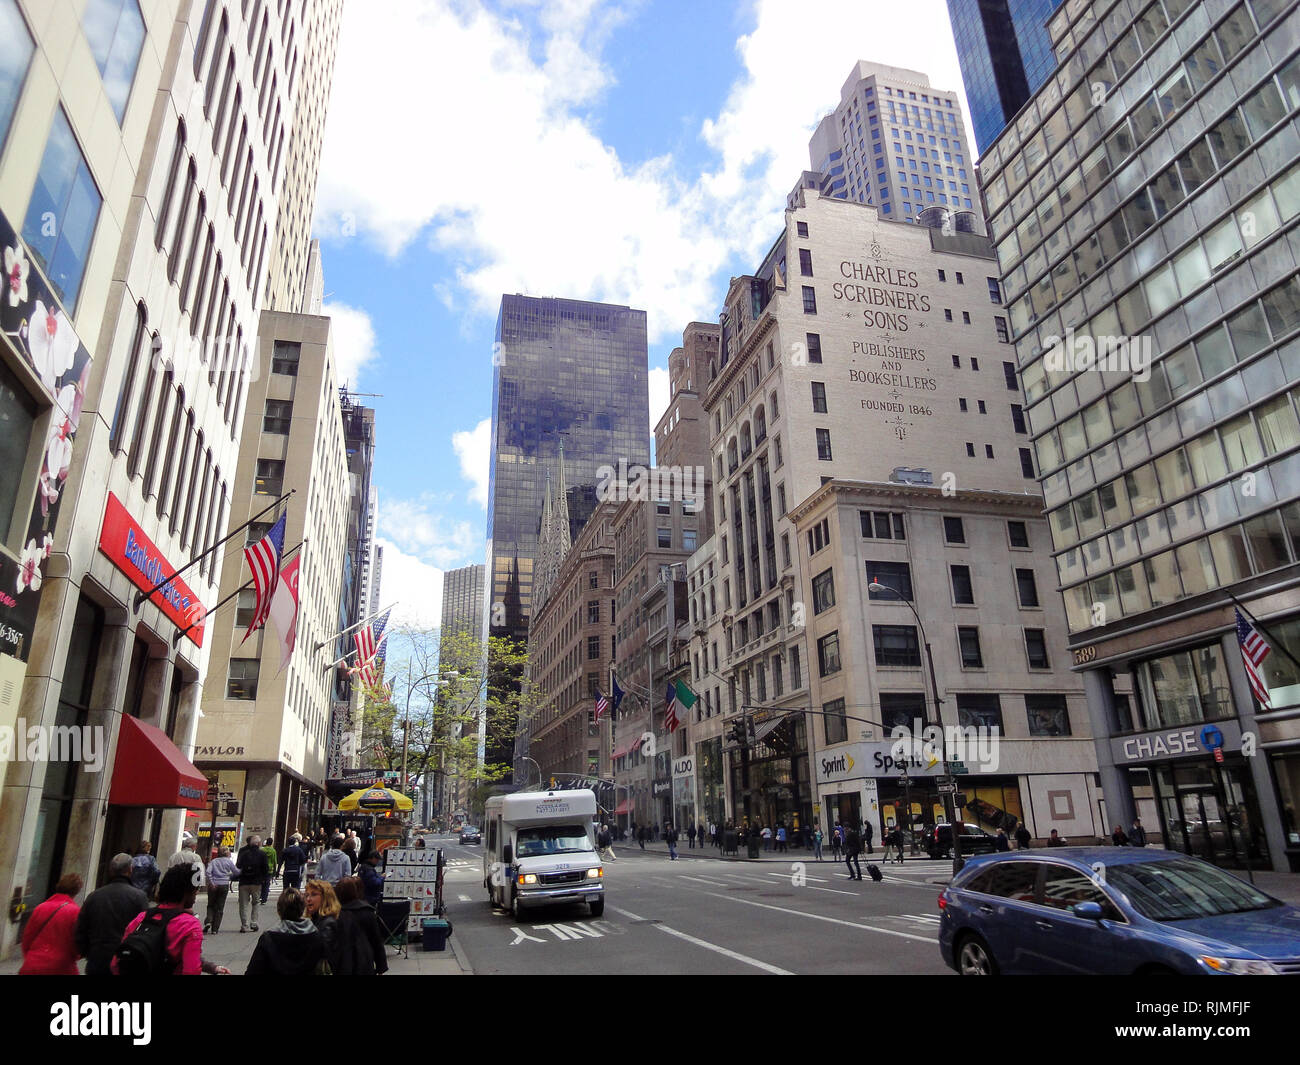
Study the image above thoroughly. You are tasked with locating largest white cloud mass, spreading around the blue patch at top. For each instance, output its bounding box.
[317,0,977,343]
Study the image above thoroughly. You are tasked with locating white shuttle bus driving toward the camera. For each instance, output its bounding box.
[482,791,605,918]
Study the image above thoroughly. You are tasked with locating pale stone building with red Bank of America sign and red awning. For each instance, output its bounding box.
[0,0,338,953]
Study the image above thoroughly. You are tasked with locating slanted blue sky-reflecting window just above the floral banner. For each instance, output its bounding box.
[22,108,103,313]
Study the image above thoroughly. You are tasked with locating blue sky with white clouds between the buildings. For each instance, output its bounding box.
[315,0,961,625]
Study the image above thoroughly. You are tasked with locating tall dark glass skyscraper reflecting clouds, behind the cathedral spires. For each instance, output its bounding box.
[488,295,650,638]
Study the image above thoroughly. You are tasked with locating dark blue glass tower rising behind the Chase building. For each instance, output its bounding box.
[948,0,1061,155]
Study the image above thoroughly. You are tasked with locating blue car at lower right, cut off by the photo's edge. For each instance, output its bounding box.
[939,847,1300,975]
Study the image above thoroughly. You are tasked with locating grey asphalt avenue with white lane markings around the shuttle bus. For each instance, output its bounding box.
[430,837,952,975]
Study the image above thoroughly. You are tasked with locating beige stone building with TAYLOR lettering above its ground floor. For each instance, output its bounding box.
[194,301,351,840]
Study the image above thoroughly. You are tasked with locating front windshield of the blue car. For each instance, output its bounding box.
[1105,858,1282,921]
